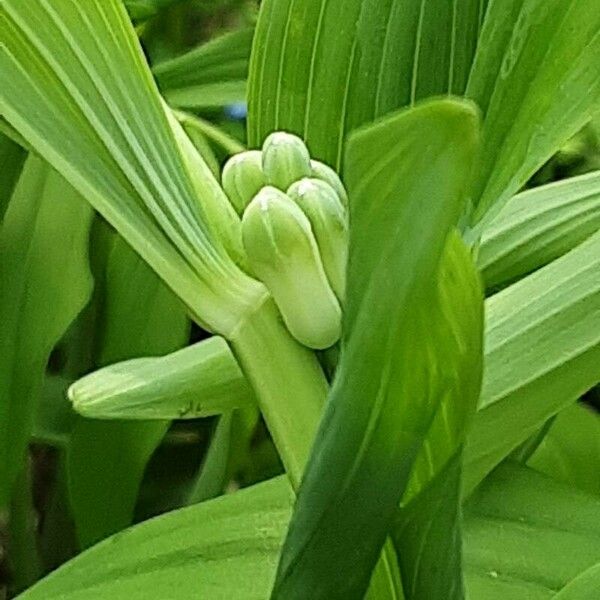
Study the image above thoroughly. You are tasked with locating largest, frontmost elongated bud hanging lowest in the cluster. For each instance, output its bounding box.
[242,186,341,349]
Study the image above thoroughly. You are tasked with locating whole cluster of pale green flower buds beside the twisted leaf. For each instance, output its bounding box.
[222,132,348,349]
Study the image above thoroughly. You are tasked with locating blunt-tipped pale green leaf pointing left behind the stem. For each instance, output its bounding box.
[69,336,254,419]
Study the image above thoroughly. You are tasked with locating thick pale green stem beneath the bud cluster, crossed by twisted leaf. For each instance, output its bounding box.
[230,298,403,600]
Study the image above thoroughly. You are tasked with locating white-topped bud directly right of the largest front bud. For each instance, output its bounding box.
[288,178,348,300]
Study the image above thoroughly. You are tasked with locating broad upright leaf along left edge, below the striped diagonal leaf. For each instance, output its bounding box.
[0,157,92,508]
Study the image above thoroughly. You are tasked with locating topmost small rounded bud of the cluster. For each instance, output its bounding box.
[262,131,311,192]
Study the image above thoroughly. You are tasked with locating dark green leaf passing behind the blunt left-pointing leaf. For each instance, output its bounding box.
[67,239,189,547]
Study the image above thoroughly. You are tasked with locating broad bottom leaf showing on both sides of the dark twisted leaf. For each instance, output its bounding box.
[19,465,600,600]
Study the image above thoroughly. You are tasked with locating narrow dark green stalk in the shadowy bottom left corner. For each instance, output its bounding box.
[8,464,42,591]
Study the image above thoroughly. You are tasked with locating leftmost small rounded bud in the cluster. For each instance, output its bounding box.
[221,150,267,215]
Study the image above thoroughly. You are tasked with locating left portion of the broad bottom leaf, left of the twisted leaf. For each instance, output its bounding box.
[19,477,293,600]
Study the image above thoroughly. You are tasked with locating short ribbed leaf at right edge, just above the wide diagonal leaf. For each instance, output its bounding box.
[477,173,600,288]
